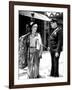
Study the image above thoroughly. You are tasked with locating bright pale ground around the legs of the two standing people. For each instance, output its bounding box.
[19,51,64,80]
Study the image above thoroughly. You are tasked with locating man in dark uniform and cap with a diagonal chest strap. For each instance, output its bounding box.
[48,19,63,77]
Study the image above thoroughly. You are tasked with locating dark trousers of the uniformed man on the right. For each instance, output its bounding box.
[50,51,60,77]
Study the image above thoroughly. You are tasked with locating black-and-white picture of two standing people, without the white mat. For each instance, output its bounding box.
[18,11,64,79]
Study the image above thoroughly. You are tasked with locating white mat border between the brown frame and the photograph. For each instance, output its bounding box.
[14,5,68,85]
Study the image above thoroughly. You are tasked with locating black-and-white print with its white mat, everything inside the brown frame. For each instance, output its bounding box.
[10,3,70,86]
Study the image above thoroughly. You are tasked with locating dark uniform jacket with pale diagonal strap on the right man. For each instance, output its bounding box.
[49,27,63,52]
